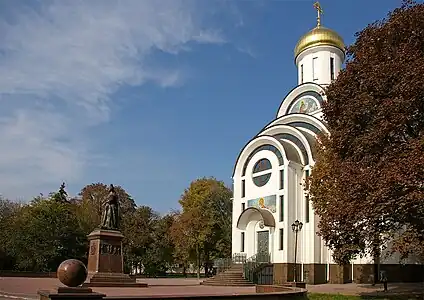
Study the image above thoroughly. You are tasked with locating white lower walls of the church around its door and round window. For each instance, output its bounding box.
[232,145,321,263]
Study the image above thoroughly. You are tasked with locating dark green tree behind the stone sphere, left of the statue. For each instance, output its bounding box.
[6,199,87,271]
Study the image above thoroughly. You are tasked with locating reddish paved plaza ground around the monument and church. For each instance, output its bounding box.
[0,277,424,300]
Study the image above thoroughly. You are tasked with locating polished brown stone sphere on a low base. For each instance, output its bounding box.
[57,259,88,287]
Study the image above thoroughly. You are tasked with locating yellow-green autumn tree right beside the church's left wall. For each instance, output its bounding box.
[172,178,232,278]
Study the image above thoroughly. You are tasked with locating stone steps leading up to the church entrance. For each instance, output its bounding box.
[201,263,254,286]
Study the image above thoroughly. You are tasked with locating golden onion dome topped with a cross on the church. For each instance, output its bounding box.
[294,2,345,60]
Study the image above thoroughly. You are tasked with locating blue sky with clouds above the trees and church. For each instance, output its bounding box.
[0,0,410,212]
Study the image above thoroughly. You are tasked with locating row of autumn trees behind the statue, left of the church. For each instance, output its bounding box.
[0,180,231,276]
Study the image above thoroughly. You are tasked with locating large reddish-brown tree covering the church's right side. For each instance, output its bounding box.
[310,1,424,264]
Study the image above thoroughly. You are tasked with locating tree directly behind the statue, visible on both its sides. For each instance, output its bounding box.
[78,183,136,232]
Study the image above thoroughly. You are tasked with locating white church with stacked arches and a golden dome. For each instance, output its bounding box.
[232,3,422,284]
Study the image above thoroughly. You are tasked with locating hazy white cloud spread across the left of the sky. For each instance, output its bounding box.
[0,0,224,197]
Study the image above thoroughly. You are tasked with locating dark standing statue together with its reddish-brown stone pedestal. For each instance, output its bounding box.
[83,184,147,287]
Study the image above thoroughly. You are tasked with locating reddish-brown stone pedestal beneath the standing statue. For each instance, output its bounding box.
[83,229,147,287]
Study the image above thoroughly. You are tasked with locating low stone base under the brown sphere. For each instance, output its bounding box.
[38,287,106,300]
